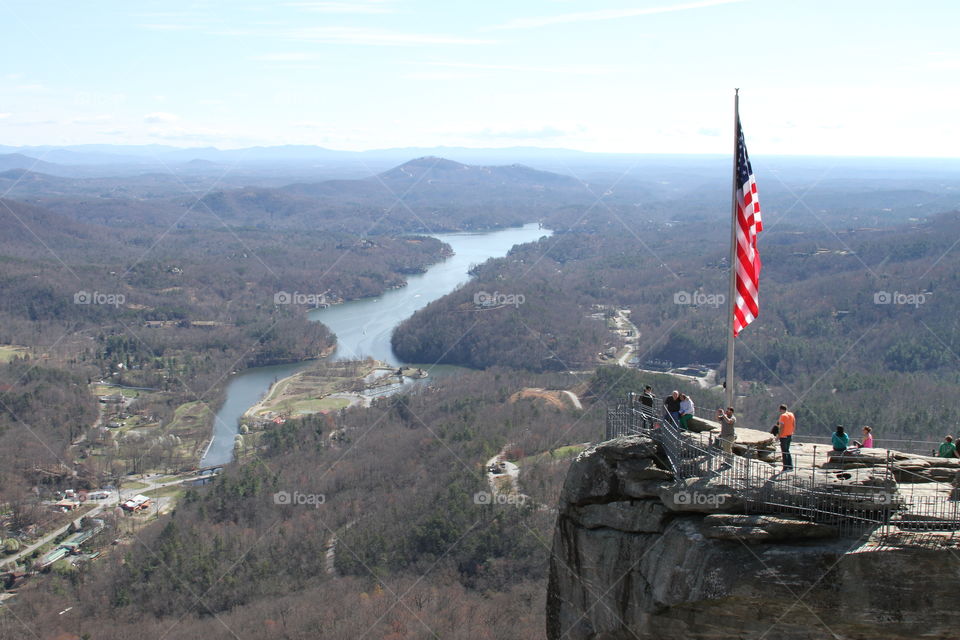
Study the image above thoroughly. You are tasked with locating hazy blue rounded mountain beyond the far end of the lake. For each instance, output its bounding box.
[203,156,594,233]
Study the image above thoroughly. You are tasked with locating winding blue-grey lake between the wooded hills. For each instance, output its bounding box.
[200,223,551,467]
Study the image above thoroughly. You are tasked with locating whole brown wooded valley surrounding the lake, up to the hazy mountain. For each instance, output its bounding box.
[0,152,960,640]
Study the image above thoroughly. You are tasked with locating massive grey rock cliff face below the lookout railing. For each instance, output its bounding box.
[547,436,960,640]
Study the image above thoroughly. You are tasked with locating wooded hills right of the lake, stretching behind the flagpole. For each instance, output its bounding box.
[394,209,960,439]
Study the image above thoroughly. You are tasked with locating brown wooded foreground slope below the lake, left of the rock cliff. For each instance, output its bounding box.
[13,370,602,640]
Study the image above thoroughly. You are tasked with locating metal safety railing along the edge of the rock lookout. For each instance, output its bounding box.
[606,395,960,542]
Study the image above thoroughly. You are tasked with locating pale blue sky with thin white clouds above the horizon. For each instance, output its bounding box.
[0,0,960,157]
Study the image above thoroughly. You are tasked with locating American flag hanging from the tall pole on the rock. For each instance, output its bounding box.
[733,117,763,336]
